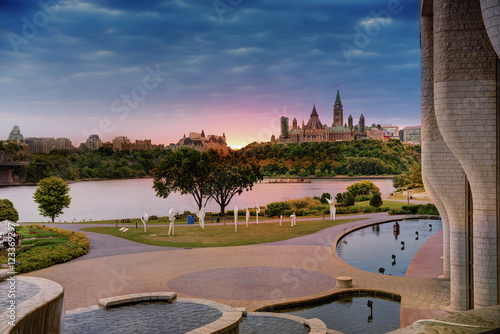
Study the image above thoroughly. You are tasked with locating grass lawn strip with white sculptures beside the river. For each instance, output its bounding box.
[83,219,359,248]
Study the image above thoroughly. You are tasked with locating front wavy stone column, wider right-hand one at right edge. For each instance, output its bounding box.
[433,0,498,308]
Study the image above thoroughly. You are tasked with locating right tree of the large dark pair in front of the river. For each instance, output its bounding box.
[209,150,263,215]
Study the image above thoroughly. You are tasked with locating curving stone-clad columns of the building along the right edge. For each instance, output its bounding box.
[420,0,500,311]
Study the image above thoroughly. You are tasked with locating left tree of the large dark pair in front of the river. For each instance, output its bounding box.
[151,148,212,209]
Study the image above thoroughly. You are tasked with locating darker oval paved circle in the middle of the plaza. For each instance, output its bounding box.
[168,267,336,300]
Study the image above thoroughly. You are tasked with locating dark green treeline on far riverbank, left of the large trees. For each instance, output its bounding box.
[25,147,170,182]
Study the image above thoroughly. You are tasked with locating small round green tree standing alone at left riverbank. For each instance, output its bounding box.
[33,176,71,222]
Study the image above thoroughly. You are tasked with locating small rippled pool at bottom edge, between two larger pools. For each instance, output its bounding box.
[240,315,309,334]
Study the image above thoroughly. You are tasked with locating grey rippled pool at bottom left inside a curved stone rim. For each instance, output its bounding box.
[63,301,222,334]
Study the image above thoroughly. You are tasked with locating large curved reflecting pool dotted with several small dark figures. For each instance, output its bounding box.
[337,219,442,276]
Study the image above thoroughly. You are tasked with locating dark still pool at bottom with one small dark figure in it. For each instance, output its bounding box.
[278,296,401,334]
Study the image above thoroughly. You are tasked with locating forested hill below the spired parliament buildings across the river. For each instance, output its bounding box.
[239,139,420,176]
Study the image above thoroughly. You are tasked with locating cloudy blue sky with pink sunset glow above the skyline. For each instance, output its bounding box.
[0,0,420,147]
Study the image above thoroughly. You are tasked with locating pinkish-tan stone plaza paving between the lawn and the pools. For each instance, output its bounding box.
[23,213,450,326]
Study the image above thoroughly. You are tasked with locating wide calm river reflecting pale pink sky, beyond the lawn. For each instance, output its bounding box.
[0,179,394,222]
